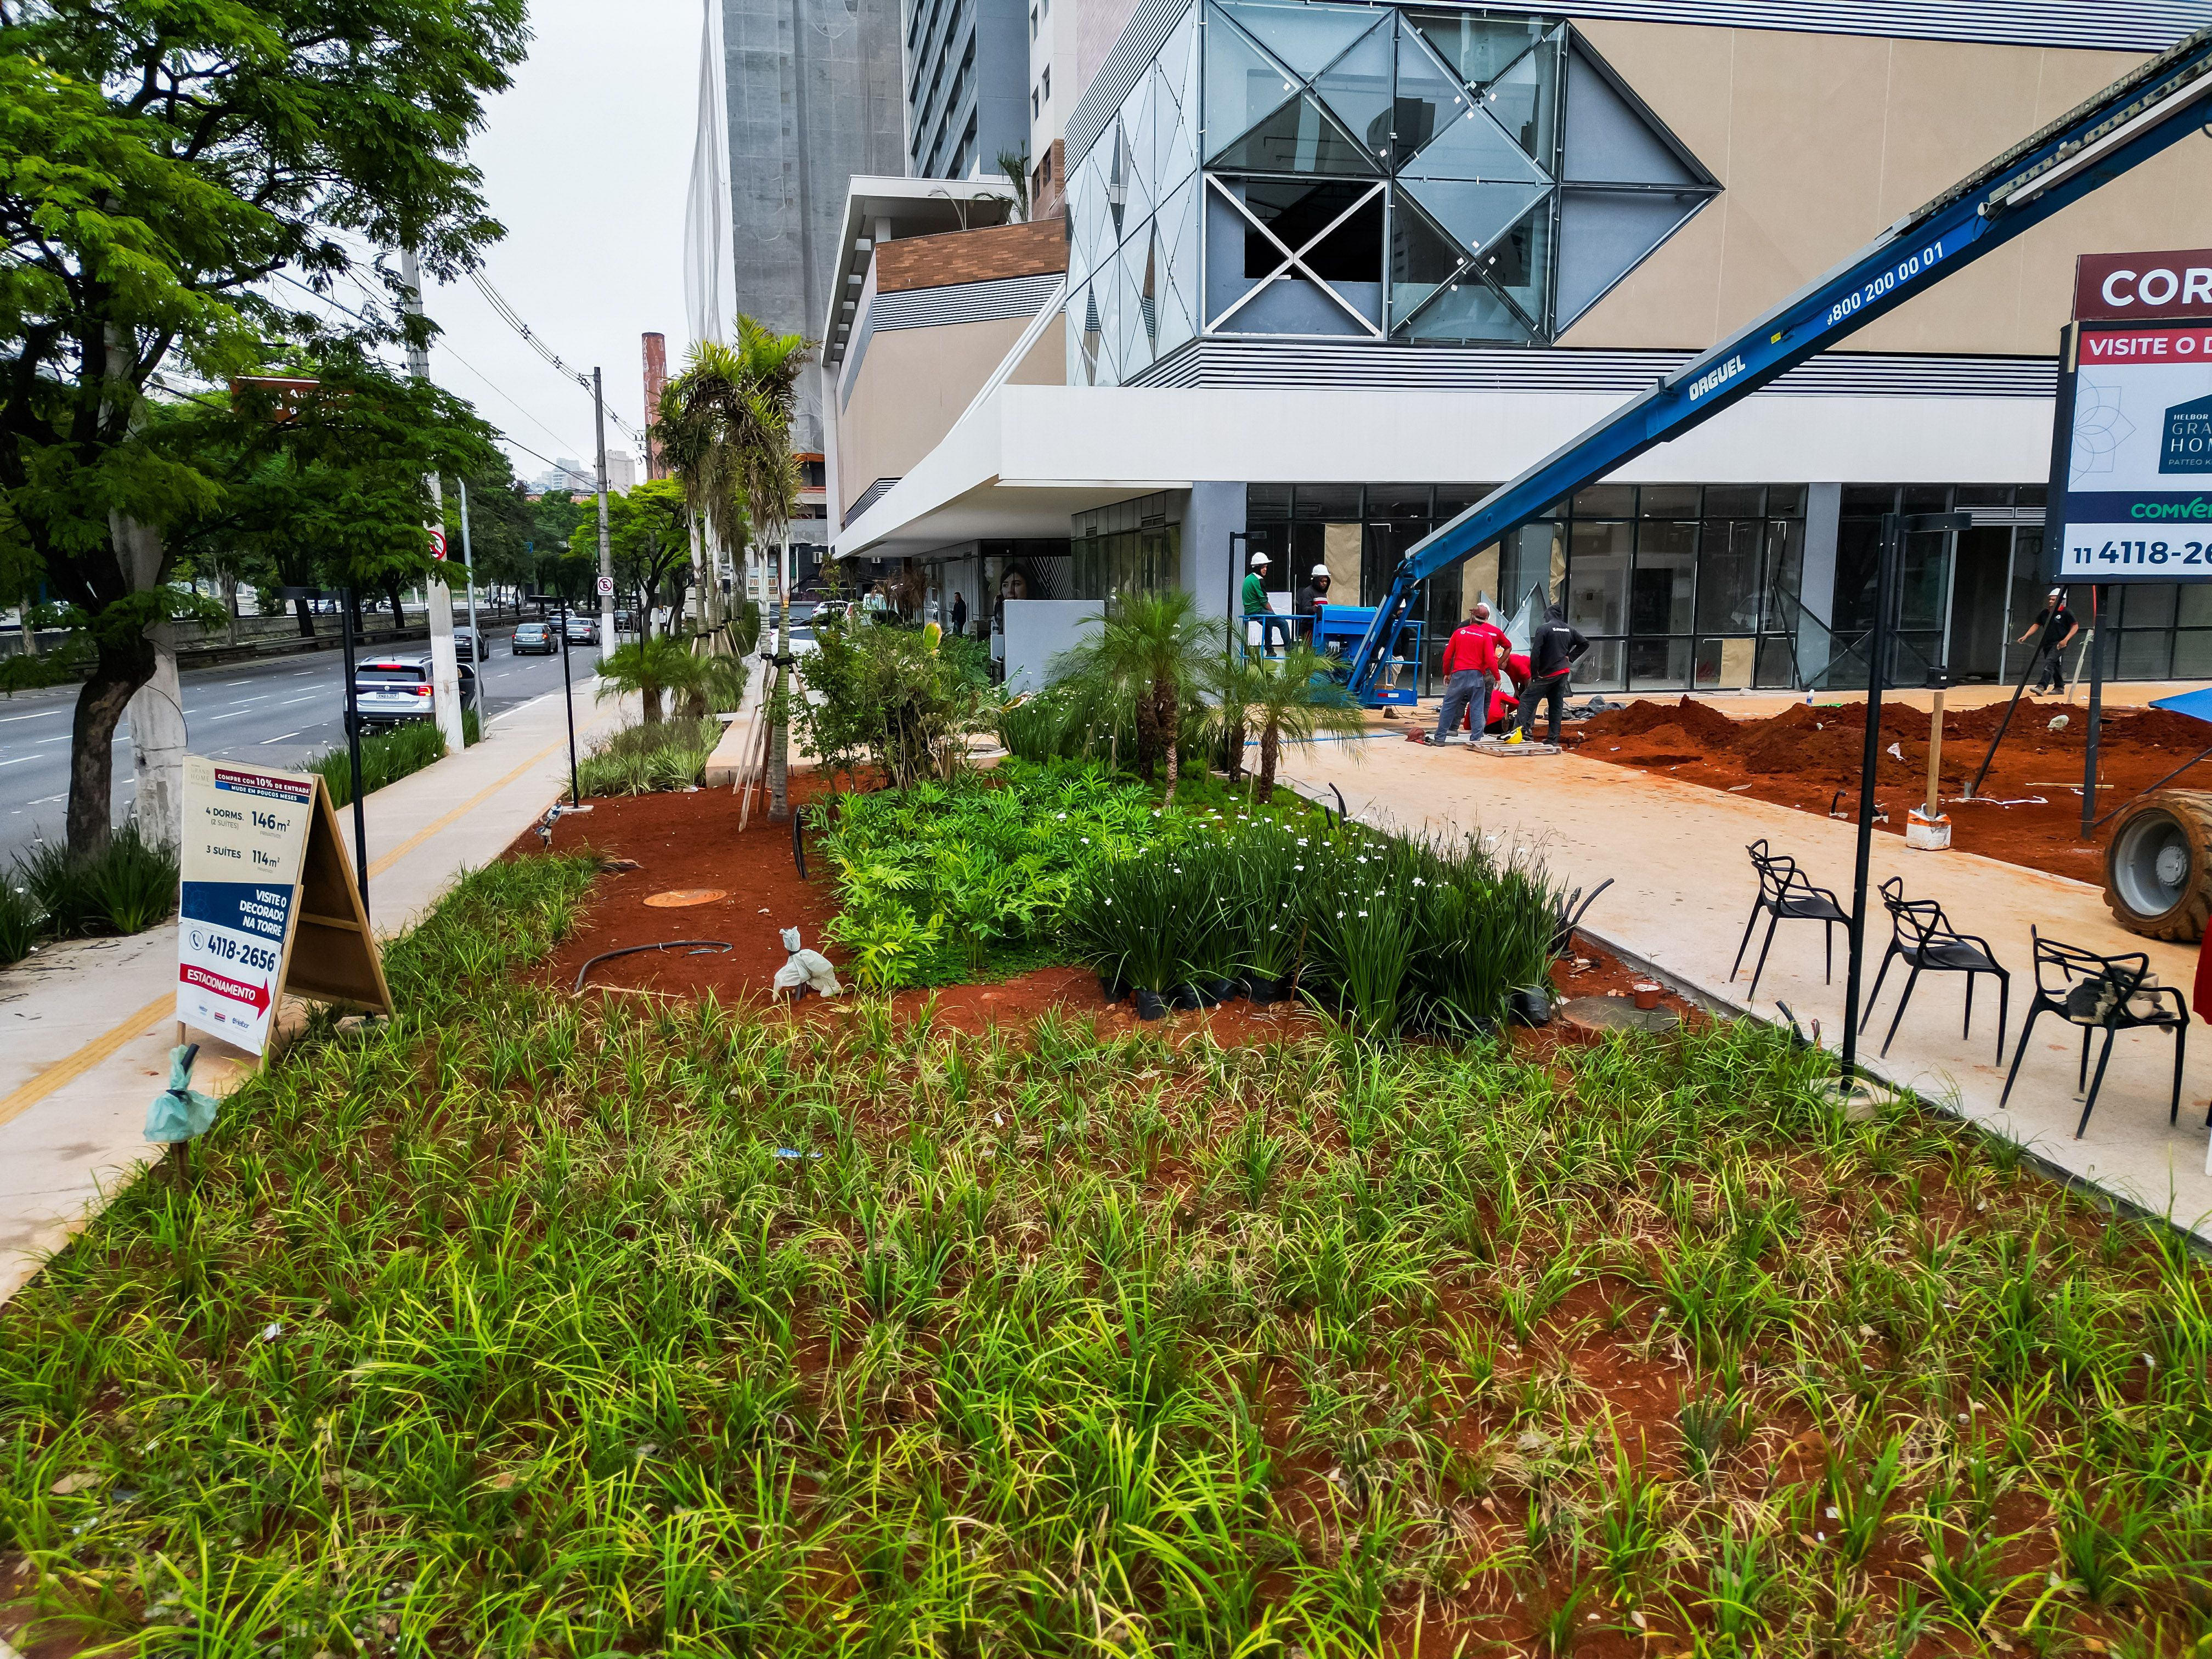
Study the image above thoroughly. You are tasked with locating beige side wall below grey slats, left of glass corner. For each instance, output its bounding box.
[836,317,1068,520]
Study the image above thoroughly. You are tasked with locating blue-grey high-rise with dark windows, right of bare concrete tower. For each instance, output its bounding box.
[905,0,1029,179]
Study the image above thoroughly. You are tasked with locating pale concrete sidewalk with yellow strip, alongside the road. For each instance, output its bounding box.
[0,681,637,1301]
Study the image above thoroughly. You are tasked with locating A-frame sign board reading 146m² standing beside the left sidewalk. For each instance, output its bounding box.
[177,754,392,1053]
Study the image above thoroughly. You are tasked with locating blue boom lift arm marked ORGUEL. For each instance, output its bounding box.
[1345,29,2212,701]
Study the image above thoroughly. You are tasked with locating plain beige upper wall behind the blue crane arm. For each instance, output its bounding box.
[1560,18,2212,356]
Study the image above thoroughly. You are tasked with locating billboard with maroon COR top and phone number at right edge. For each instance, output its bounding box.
[2049,252,2212,582]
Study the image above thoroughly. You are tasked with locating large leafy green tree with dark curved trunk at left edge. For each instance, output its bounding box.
[0,0,527,856]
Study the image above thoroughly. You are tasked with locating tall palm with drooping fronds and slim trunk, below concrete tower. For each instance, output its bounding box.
[657,317,808,819]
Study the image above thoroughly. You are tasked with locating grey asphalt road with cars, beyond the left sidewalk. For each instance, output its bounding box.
[0,630,600,870]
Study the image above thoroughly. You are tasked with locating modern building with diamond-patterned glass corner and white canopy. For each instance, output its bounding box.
[838,0,2212,690]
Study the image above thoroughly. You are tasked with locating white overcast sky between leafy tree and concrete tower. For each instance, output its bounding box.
[422,0,699,478]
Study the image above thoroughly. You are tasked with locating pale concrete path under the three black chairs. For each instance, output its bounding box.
[1285,734,2212,1239]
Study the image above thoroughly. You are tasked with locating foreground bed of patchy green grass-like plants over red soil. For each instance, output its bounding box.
[0,858,2212,1659]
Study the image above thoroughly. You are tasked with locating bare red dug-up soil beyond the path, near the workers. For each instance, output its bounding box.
[1568,697,2212,883]
